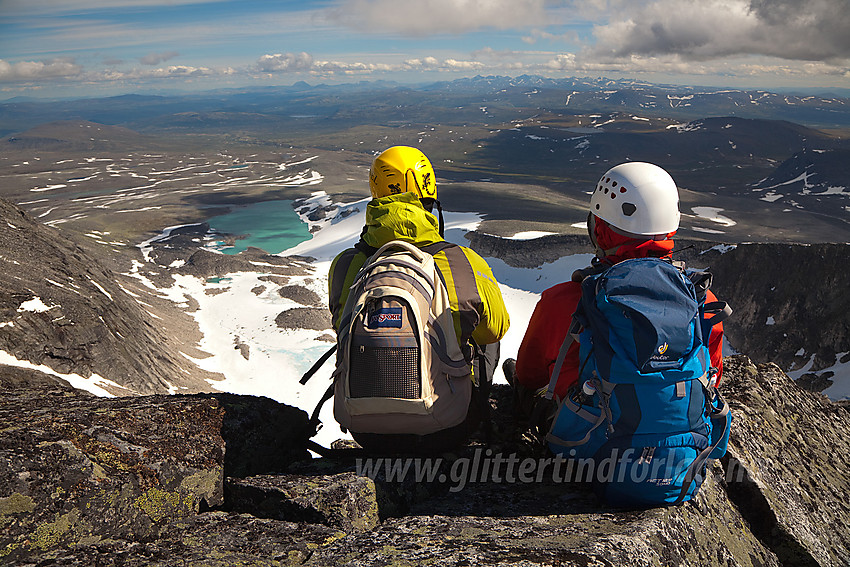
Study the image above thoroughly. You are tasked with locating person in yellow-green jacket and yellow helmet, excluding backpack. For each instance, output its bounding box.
[328,146,510,451]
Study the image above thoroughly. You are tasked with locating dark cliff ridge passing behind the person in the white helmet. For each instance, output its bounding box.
[468,233,850,386]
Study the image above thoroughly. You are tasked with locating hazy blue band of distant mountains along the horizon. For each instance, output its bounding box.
[0,75,850,135]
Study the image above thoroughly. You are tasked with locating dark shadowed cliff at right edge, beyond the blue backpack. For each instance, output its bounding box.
[705,244,850,371]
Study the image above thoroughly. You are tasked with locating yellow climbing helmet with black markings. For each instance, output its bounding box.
[369,146,437,199]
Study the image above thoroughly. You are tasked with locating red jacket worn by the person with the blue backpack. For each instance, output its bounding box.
[516,219,723,399]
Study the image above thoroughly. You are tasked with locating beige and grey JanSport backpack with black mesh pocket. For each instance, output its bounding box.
[334,240,473,435]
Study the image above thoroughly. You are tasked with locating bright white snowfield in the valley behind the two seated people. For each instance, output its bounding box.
[122,191,850,446]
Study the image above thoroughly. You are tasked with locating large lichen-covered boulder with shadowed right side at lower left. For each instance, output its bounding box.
[0,382,311,564]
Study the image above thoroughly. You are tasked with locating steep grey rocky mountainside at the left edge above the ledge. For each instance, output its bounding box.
[0,200,209,395]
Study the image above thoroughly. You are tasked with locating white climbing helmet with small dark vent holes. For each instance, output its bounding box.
[590,161,679,236]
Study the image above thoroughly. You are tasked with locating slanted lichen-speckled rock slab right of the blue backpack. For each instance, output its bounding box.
[722,356,850,565]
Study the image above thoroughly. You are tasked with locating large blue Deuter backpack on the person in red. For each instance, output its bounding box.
[546,258,731,507]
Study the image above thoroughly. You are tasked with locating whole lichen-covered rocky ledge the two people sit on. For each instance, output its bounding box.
[0,356,850,566]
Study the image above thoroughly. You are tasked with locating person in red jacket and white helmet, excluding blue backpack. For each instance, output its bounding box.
[504,162,723,427]
